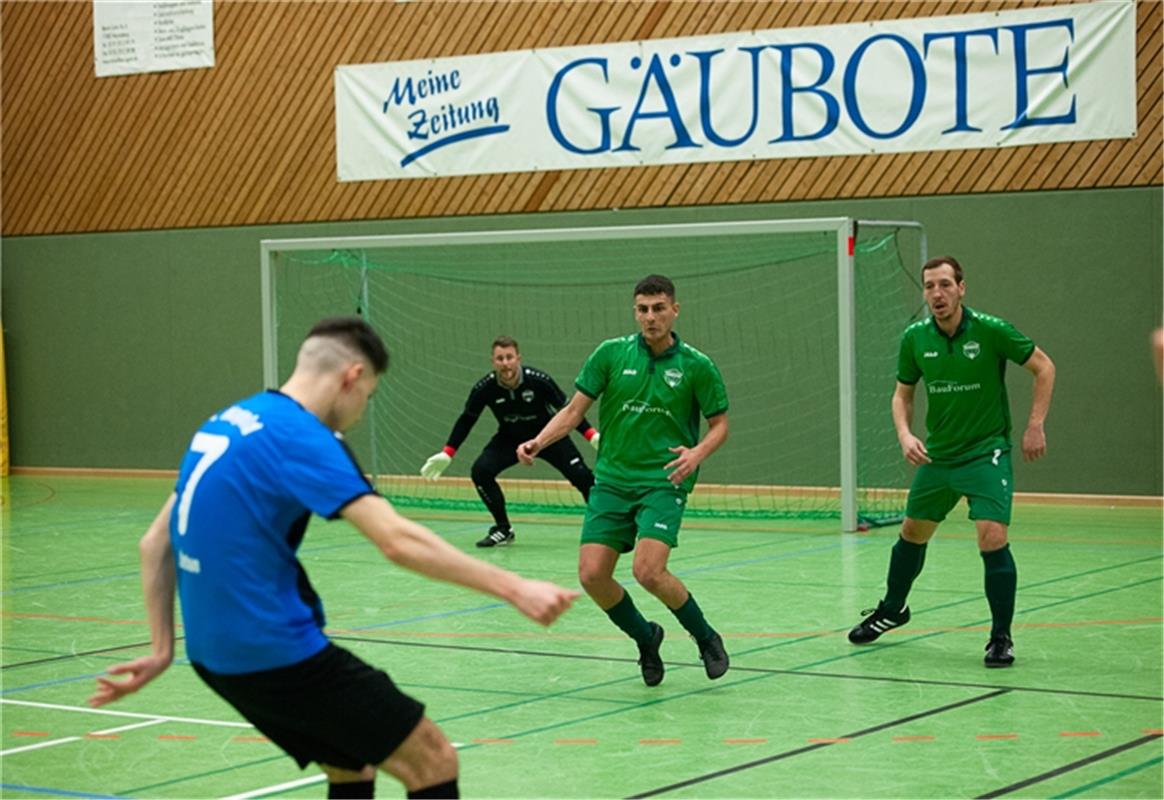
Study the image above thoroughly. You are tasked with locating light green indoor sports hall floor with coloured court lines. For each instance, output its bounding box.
[0,476,1164,798]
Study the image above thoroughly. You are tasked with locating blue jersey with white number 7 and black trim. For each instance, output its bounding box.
[170,391,375,673]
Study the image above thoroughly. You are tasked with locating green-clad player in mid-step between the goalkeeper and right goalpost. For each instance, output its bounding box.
[518,275,729,686]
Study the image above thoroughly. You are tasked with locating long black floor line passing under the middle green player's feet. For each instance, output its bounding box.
[331,636,1164,702]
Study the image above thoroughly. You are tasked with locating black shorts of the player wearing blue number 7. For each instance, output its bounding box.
[193,643,425,770]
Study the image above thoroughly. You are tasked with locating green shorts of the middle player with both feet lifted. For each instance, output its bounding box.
[582,483,687,553]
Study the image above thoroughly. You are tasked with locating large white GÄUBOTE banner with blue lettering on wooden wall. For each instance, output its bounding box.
[335,0,1136,180]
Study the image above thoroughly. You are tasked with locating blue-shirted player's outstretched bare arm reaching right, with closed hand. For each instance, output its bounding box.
[341,494,579,625]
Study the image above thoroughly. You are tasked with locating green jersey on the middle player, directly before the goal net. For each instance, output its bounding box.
[574,334,728,491]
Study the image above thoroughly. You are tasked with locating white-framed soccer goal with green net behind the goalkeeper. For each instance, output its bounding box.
[262,218,925,531]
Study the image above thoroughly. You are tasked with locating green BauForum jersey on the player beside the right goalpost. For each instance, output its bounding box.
[897,306,1035,463]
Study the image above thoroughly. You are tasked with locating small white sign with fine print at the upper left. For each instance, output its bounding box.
[93,0,214,78]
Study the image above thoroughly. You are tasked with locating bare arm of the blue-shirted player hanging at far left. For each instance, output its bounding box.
[88,494,177,707]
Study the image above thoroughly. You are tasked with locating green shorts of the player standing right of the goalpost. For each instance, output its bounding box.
[906,449,1014,525]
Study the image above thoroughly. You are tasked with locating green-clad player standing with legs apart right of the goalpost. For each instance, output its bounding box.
[849,256,1055,667]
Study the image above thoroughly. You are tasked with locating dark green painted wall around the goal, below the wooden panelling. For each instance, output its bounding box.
[0,187,1164,495]
